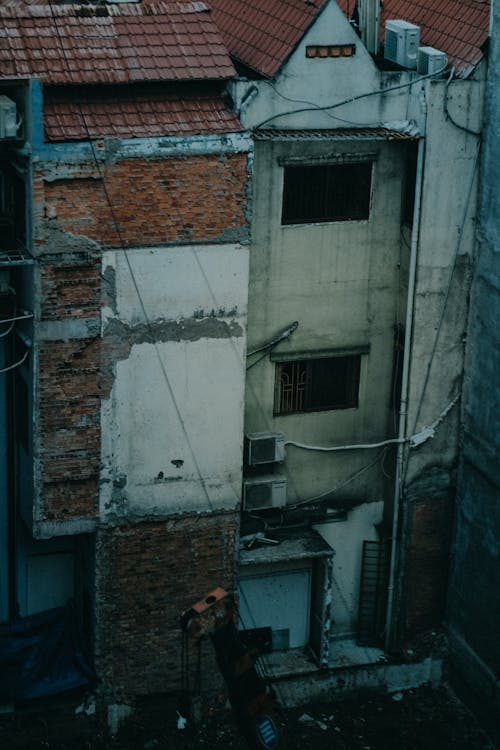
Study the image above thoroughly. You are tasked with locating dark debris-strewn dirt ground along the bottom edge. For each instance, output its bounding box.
[0,687,498,750]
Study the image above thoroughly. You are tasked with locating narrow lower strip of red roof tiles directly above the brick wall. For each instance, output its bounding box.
[44,85,243,141]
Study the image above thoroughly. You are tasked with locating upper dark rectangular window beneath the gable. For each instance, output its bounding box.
[281,162,372,224]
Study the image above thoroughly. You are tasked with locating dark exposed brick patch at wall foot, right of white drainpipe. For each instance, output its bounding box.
[405,497,452,636]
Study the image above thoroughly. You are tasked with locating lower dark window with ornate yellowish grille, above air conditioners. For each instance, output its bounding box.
[274,355,361,414]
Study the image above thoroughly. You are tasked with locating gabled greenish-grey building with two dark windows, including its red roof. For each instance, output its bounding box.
[212,0,488,657]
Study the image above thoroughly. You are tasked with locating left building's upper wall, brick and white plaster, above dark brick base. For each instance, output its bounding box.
[33,138,249,535]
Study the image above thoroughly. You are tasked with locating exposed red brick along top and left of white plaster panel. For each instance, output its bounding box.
[33,148,248,519]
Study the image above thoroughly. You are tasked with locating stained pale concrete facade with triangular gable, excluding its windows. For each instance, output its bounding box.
[236,3,484,640]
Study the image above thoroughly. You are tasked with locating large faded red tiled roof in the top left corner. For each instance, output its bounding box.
[0,2,235,84]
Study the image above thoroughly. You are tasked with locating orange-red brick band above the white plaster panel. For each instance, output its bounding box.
[44,154,247,246]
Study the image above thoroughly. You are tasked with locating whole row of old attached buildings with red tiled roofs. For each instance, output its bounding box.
[0,0,489,736]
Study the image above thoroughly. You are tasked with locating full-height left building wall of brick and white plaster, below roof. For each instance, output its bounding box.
[26,92,251,703]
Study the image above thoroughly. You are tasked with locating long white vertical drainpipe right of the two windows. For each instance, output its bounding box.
[385,123,427,651]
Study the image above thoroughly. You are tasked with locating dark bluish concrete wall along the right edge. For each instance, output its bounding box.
[449,2,500,740]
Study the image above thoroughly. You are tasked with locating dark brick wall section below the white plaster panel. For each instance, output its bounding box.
[96,513,237,697]
